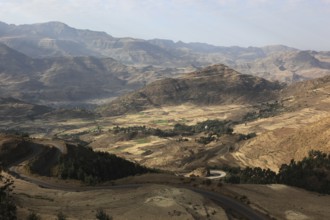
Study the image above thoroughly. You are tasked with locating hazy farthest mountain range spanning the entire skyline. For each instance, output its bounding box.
[0,22,330,83]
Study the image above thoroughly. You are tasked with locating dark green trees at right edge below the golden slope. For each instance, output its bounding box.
[222,151,330,194]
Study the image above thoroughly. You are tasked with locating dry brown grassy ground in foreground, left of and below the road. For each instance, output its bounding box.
[14,174,227,220]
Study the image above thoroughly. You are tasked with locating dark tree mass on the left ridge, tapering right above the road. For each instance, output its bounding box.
[57,146,155,184]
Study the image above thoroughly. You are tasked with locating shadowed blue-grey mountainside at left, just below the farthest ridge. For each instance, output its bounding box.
[0,44,183,104]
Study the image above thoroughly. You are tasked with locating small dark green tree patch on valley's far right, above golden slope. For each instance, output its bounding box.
[242,101,283,121]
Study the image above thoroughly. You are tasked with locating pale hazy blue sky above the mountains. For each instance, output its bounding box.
[0,0,330,50]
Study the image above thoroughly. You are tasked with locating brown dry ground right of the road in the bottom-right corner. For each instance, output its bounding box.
[225,184,330,220]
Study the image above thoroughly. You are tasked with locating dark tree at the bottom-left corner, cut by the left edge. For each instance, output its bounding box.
[0,167,17,220]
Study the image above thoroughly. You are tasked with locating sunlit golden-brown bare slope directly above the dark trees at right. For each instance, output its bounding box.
[233,116,330,171]
